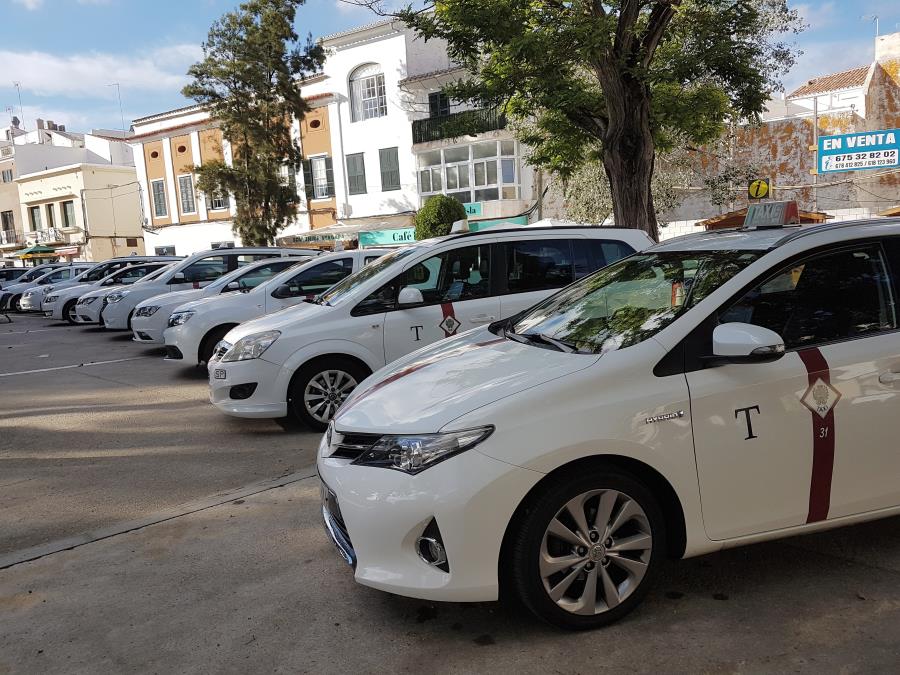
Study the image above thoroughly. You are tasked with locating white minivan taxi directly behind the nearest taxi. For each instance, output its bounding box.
[209,227,653,429]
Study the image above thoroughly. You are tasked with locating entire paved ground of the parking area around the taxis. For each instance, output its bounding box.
[0,320,900,674]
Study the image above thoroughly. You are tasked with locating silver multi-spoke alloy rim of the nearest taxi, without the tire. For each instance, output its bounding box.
[539,490,653,615]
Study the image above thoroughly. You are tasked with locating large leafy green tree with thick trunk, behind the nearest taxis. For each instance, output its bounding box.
[398,0,803,242]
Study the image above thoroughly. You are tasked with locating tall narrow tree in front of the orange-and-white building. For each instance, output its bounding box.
[182,0,324,245]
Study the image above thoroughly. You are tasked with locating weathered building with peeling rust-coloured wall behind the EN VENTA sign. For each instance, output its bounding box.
[660,33,900,243]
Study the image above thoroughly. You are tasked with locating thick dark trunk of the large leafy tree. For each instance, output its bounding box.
[603,76,659,241]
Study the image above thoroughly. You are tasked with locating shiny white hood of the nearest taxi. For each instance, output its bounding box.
[335,328,599,433]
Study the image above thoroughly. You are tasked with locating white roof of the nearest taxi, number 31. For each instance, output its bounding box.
[647,218,900,253]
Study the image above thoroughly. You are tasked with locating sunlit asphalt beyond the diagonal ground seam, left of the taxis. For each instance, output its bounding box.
[0,315,319,556]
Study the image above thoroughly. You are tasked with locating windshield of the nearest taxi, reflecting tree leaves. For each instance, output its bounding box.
[499,251,761,354]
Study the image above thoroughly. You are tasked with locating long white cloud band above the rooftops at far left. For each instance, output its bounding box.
[0,45,202,99]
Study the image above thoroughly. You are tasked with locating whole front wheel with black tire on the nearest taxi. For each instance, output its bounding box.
[506,467,666,630]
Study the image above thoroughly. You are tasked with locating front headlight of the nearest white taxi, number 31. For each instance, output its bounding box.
[353,426,494,475]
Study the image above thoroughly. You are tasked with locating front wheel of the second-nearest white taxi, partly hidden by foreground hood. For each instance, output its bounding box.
[288,356,370,431]
